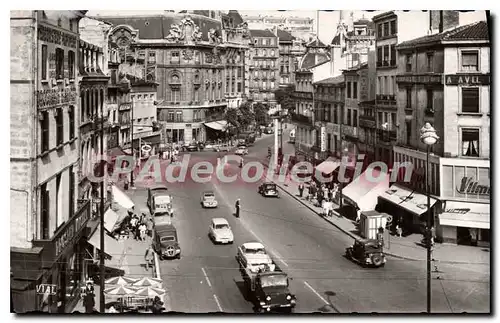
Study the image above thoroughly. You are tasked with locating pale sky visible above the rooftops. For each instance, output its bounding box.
[87,10,486,44]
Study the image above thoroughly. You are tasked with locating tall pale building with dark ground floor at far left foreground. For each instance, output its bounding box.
[10,10,91,313]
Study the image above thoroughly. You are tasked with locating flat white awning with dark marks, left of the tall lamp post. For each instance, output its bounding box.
[380,184,437,215]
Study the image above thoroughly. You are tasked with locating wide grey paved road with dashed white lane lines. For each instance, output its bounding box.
[124,130,490,313]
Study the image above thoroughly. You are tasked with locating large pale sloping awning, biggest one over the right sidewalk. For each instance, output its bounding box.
[342,168,390,211]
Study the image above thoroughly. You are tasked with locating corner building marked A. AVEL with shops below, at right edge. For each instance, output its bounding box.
[382,21,491,245]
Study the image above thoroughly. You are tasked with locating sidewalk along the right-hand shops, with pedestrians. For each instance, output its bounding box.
[264,149,490,264]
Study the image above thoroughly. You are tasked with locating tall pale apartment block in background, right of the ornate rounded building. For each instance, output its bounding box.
[250,29,279,108]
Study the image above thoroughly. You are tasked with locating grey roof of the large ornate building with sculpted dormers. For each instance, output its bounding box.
[98,12,222,41]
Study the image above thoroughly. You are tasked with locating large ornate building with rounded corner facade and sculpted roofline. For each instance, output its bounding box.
[95,12,244,143]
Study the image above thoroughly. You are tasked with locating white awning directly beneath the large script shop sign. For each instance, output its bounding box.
[439,201,490,229]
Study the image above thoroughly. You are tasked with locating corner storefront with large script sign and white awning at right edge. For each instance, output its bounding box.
[436,158,491,246]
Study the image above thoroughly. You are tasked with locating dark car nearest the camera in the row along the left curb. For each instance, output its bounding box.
[153,223,181,260]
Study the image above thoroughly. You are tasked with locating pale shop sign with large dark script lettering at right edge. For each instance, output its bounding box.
[441,165,491,200]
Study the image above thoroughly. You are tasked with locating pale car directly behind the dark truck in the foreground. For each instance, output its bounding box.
[236,242,276,273]
